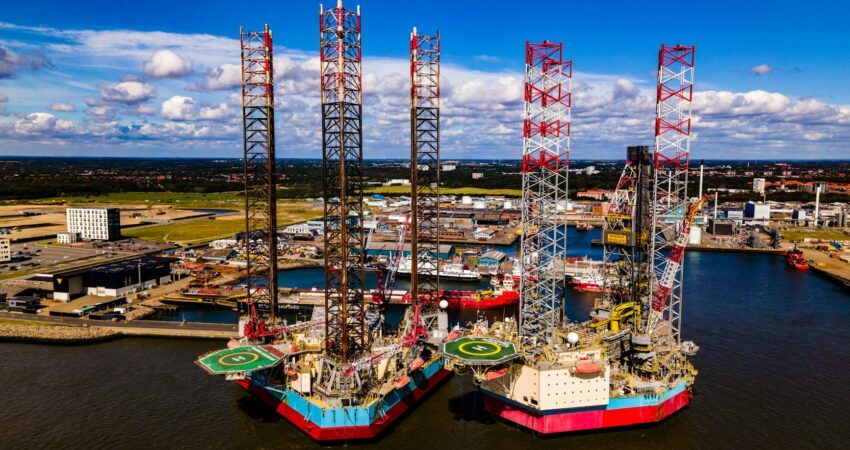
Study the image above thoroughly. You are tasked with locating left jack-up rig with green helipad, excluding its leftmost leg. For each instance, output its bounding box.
[198,0,451,442]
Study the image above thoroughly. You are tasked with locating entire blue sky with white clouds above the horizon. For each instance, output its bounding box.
[0,0,850,159]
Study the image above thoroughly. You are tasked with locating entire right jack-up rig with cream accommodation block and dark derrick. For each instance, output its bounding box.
[443,43,702,434]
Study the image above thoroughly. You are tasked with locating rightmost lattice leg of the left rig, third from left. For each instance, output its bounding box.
[410,28,440,329]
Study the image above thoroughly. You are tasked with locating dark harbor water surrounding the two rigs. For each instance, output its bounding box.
[0,232,850,450]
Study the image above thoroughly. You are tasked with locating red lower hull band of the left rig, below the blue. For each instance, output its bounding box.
[237,369,451,442]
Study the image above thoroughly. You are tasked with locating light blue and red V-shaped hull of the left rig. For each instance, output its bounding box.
[237,358,452,443]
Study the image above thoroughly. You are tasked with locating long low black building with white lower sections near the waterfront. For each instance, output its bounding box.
[53,256,171,302]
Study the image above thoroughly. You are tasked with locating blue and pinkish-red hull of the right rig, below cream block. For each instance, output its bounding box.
[482,382,693,435]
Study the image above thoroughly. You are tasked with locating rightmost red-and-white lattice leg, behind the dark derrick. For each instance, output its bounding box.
[652,44,695,343]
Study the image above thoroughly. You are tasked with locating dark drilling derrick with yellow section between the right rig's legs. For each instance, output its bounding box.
[602,146,654,318]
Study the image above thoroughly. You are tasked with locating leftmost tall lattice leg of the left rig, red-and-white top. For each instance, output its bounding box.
[240,25,277,339]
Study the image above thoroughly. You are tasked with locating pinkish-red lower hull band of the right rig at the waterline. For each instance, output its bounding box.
[484,390,693,434]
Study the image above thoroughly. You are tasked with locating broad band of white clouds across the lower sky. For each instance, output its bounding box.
[0,25,850,158]
